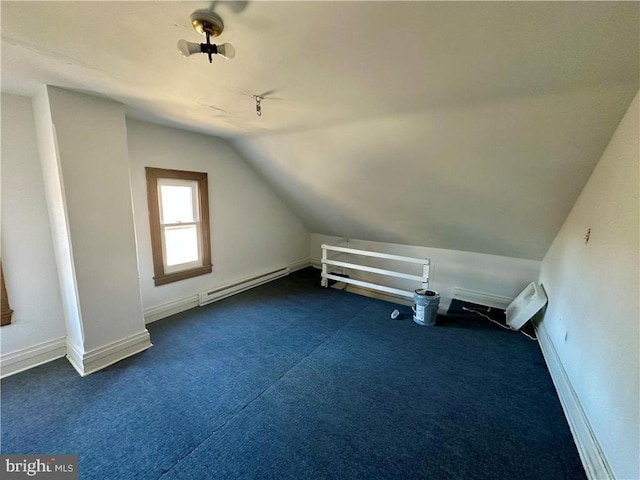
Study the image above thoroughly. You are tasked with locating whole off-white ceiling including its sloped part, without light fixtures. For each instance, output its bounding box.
[0,1,640,259]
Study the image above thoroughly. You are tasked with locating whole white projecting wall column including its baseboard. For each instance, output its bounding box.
[33,86,151,376]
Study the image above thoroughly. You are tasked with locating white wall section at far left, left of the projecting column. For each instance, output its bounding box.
[0,94,65,356]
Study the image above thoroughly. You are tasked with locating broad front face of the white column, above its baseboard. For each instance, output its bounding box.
[38,87,148,353]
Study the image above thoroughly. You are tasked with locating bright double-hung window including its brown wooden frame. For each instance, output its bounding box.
[145,167,211,286]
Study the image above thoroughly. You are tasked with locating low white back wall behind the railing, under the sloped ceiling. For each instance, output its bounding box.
[310,234,540,311]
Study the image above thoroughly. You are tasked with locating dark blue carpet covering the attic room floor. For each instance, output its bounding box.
[1,269,586,480]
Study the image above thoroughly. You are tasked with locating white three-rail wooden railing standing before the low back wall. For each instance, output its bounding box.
[322,244,429,299]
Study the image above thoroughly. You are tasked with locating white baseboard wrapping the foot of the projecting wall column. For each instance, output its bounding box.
[67,329,152,377]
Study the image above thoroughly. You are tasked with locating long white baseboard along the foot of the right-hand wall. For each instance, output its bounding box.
[536,323,615,480]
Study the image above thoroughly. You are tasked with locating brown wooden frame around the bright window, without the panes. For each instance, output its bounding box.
[145,167,212,286]
